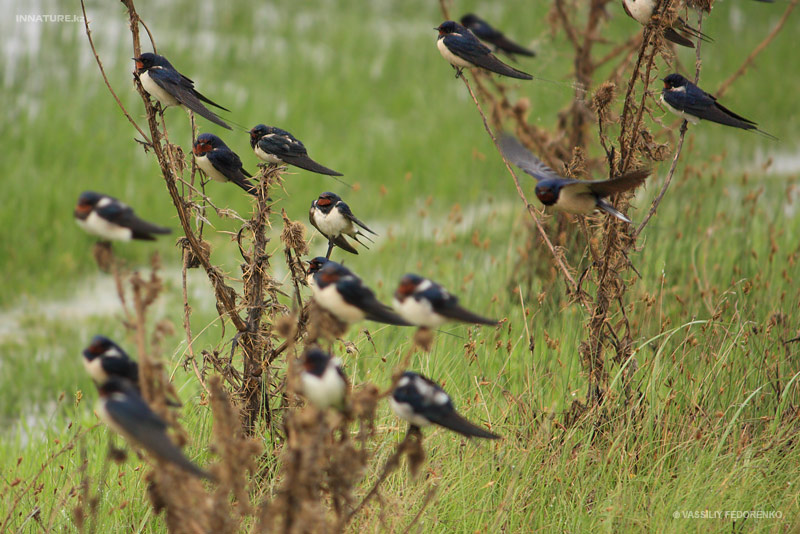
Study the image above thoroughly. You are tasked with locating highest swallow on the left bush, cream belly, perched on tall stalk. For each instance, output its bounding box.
[133,52,232,130]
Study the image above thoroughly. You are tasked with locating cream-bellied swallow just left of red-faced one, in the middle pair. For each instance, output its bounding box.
[311,261,411,326]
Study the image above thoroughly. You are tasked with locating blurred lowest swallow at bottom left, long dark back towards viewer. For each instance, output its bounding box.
[97,378,214,480]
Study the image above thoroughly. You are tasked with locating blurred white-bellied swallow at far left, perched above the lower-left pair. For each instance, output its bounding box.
[74,191,172,241]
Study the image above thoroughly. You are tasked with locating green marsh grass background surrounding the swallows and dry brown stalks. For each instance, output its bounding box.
[0,0,800,532]
